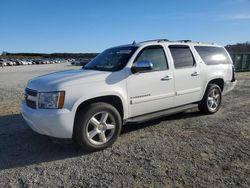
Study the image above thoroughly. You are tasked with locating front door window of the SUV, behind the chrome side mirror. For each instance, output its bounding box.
[136,47,168,71]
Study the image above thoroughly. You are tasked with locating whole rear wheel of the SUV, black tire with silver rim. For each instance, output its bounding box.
[198,84,222,114]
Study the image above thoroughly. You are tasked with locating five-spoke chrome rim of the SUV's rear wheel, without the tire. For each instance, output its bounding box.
[207,88,221,111]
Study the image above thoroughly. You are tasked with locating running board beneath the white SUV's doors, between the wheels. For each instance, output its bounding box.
[124,104,197,124]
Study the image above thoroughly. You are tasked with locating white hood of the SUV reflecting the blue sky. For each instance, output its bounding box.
[27,69,111,92]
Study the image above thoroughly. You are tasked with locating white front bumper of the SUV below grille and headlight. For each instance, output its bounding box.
[22,101,74,138]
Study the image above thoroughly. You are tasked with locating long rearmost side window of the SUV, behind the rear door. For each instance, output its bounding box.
[195,46,231,65]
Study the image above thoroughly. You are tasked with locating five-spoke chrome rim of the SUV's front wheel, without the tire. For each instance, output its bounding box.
[86,111,116,145]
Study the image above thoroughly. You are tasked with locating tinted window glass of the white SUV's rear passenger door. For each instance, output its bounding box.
[169,46,195,69]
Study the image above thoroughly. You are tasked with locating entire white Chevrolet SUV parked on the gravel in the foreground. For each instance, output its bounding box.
[22,39,236,151]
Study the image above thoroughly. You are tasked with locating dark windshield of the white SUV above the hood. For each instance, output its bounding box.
[83,47,137,72]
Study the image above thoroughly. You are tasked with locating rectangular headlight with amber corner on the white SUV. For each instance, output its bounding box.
[38,91,65,109]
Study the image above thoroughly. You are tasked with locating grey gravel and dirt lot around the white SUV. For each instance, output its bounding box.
[0,65,250,187]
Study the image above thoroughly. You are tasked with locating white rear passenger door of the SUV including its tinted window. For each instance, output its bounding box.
[169,45,201,106]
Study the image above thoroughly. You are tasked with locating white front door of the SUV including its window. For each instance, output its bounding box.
[127,45,175,117]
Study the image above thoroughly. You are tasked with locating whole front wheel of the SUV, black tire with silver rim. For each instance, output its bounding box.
[74,102,122,151]
